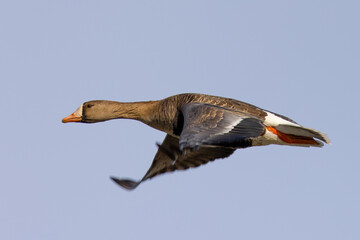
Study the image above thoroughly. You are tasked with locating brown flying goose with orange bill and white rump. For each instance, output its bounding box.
[62,93,330,190]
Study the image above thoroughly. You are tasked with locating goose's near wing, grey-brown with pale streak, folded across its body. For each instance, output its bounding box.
[179,103,265,150]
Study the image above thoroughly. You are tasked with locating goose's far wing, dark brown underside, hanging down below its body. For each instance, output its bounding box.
[111,134,235,190]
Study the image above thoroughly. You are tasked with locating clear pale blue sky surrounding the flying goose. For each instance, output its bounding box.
[0,0,360,240]
